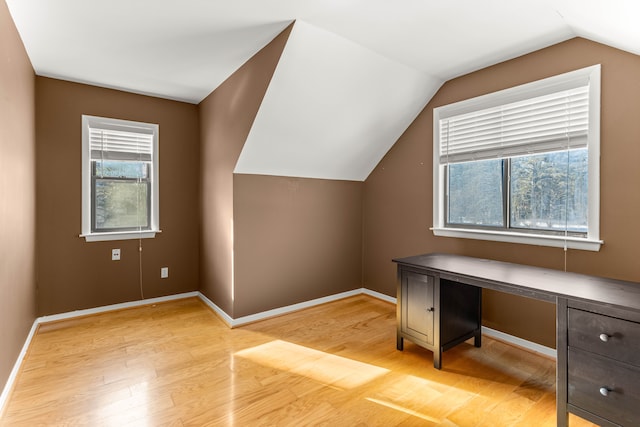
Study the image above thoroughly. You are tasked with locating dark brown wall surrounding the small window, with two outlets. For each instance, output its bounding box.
[36,77,200,315]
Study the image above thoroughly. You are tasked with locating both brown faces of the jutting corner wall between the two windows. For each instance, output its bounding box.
[200,22,362,318]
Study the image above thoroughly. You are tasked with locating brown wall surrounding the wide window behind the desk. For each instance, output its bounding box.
[364,38,640,347]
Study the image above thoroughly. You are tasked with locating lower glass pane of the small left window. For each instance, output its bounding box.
[94,179,149,230]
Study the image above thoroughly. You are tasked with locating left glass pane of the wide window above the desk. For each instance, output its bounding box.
[447,159,504,227]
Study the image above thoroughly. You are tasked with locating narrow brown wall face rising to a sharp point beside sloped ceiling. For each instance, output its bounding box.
[199,26,292,317]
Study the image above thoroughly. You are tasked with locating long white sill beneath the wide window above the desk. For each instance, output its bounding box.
[431,227,604,252]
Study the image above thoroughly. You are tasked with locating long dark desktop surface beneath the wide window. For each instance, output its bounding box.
[393,253,640,311]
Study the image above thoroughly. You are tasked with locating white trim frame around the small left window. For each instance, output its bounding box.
[80,115,161,242]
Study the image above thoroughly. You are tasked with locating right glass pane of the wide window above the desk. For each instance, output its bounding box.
[510,148,588,233]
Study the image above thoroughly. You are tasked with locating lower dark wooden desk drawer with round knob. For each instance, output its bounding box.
[568,348,640,426]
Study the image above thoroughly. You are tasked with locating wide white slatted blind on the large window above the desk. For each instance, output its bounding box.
[439,82,589,164]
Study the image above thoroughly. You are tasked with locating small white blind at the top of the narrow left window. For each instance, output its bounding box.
[89,123,154,162]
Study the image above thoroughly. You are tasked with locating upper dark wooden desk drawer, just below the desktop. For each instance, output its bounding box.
[569,308,640,366]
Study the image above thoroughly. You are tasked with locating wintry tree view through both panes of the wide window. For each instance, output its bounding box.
[446,148,588,234]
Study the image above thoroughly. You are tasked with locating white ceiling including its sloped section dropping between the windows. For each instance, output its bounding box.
[5,0,640,180]
